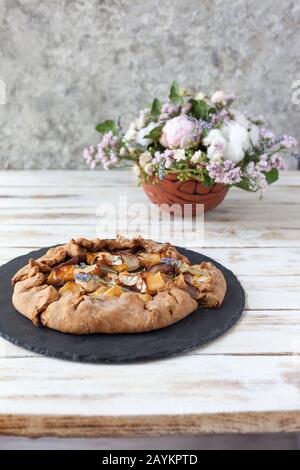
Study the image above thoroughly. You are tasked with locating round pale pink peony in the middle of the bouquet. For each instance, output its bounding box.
[160,114,201,149]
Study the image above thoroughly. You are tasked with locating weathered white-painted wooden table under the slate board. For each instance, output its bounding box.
[0,171,300,437]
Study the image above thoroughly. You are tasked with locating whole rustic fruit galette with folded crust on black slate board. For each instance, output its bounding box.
[12,237,226,335]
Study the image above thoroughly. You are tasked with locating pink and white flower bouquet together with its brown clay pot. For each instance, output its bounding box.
[84,81,297,210]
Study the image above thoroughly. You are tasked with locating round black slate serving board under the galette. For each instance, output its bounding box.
[0,247,245,364]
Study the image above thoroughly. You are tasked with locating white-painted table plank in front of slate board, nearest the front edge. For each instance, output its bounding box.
[0,355,300,416]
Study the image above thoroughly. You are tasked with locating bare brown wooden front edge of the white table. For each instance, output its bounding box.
[0,410,300,436]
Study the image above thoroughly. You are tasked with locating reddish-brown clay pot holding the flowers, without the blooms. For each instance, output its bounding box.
[143,174,228,213]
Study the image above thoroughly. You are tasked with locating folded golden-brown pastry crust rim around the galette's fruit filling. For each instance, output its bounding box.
[12,237,226,334]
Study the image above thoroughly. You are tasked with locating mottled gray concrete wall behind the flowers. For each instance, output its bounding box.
[0,0,300,169]
